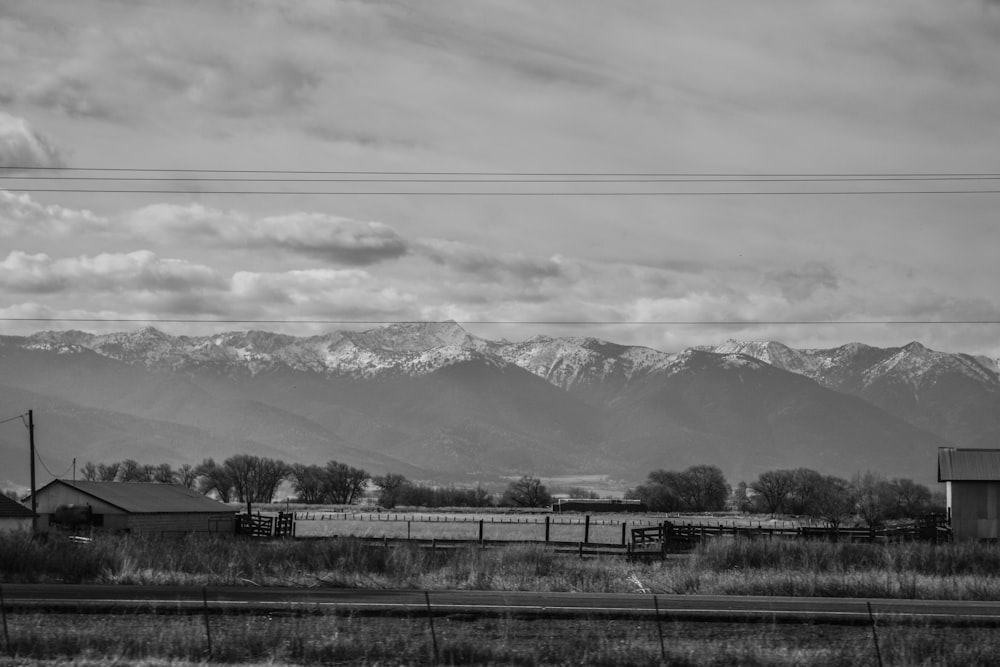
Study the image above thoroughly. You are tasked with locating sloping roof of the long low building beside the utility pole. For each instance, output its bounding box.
[38,479,236,514]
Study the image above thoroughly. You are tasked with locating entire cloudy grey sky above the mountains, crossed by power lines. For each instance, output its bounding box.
[0,0,1000,356]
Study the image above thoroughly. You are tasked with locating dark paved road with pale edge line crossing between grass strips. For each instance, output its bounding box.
[0,584,1000,627]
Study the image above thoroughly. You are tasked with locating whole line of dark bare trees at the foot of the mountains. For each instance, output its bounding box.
[74,454,944,528]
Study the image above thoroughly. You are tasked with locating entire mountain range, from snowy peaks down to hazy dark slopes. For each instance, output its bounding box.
[0,322,1000,484]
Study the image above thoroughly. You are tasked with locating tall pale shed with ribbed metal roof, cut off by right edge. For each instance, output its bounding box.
[938,447,1000,540]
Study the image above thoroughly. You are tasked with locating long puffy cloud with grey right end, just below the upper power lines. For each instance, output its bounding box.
[130,204,409,266]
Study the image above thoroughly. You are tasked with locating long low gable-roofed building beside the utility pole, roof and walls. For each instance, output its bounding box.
[30,479,236,535]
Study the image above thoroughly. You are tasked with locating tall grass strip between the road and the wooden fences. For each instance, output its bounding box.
[0,533,1000,600]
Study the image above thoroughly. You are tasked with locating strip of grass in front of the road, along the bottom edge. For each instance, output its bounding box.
[0,613,1000,667]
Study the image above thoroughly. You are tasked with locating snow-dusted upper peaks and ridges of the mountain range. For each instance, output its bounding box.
[24,321,1000,400]
